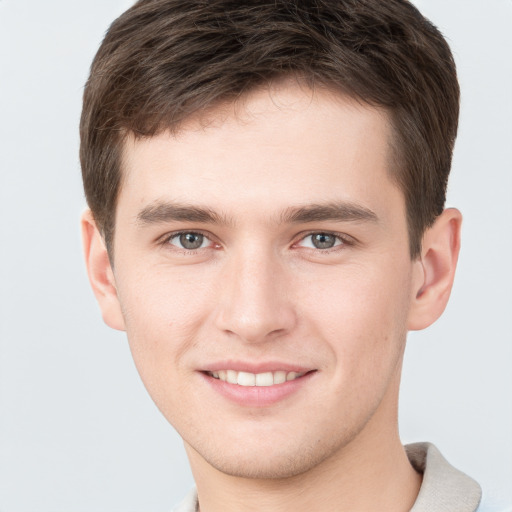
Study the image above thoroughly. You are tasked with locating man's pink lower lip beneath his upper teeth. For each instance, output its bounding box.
[201,371,316,407]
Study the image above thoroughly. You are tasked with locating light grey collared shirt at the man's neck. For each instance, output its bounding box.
[173,443,498,512]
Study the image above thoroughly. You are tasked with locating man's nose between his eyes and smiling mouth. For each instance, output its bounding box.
[216,245,297,343]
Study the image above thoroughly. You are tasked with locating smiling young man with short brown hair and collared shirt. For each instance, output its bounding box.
[81,0,492,512]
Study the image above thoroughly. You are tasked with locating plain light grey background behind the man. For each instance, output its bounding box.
[0,0,512,512]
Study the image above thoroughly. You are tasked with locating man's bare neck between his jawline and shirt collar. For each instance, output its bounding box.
[186,384,421,512]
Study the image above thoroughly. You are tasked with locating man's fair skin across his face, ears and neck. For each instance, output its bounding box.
[82,83,461,512]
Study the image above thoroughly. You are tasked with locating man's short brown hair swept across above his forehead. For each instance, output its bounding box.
[80,0,459,257]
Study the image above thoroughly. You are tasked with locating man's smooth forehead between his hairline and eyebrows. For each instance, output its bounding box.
[120,83,400,220]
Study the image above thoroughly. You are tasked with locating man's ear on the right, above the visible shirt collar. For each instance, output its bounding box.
[408,208,462,331]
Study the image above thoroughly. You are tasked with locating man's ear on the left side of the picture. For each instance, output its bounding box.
[81,209,125,331]
